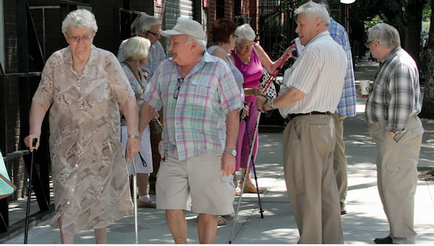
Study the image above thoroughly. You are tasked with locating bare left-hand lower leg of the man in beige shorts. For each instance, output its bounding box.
[166,209,186,244]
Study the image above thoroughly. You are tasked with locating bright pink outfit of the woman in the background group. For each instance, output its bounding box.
[231,49,264,171]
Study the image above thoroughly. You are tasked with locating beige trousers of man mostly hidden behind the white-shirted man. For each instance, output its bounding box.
[332,113,348,210]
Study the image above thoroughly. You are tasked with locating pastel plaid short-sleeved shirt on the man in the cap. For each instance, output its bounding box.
[143,52,243,161]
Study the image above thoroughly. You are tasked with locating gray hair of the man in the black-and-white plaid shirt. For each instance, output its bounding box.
[368,23,401,48]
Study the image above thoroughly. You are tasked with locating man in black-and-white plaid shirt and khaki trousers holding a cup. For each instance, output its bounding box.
[359,23,424,244]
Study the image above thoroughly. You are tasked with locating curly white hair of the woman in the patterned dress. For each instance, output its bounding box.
[62,9,98,34]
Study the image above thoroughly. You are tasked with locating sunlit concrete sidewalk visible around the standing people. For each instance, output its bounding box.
[5,56,434,244]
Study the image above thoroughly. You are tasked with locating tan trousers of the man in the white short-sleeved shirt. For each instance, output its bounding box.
[283,115,344,244]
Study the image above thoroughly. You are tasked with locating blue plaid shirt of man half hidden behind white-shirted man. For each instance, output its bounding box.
[328,17,356,116]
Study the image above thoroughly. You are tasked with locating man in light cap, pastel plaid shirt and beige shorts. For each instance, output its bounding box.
[139,17,243,243]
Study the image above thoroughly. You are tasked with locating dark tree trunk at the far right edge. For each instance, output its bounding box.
[419,1,434,119]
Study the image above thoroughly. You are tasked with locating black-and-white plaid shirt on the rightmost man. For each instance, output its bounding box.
[366,46,422,134]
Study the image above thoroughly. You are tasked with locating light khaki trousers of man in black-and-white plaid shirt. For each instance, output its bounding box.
[369,116,423,244]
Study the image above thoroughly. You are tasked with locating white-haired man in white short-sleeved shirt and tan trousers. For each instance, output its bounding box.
[257,1,347,244]
